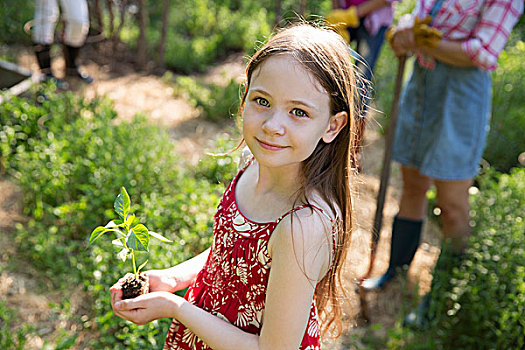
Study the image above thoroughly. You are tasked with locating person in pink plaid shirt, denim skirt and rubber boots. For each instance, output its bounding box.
[363,0,523,325]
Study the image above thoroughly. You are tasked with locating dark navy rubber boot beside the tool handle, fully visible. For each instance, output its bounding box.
[362,216,423,291]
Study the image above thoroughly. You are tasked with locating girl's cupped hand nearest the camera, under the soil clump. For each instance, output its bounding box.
[111,287,186,325]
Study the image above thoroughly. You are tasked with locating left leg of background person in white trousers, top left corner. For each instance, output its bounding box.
[32,0,59,78]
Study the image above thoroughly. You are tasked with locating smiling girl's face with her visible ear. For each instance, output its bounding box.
[243,55,346,172]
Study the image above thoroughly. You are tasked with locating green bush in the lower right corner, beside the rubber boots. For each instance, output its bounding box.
[389,169,525,349]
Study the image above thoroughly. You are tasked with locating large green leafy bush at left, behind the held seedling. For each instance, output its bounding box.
[0,87,235,349]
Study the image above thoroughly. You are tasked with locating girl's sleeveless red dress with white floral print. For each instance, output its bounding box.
[164,161,336,350]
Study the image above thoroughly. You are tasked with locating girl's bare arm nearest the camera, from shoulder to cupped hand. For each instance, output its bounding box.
[112,210,331,350]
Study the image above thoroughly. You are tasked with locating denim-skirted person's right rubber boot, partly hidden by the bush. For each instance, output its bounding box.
[403,244,464,330]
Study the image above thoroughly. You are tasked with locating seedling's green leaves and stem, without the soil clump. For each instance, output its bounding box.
[89,187,172,279]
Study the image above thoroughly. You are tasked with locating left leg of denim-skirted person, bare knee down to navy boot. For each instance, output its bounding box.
[362,166,432,290]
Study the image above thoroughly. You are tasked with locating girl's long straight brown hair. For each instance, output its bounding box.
[239,24,358,336]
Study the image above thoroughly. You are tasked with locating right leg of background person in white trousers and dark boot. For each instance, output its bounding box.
[60,0,93,83]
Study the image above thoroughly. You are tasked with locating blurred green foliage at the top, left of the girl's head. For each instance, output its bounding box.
[129,0,273,73]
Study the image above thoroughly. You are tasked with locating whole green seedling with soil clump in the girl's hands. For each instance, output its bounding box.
[88,187,171,299]
